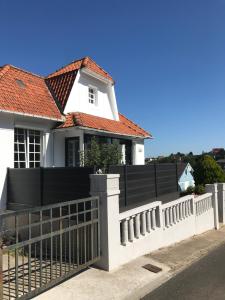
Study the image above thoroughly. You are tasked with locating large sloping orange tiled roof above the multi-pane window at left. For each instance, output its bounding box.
[0,65,62,120]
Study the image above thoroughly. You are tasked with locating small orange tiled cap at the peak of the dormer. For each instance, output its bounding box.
[46,56,113,81]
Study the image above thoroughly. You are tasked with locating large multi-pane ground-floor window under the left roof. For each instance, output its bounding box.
[14,128,41,168]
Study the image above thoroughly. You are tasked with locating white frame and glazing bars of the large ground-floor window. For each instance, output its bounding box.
[14,127,43,168]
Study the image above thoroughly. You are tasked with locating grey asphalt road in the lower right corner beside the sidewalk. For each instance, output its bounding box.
[143,244,225,300]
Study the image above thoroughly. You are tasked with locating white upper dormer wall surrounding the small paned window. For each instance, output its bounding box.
[64,71,118,120]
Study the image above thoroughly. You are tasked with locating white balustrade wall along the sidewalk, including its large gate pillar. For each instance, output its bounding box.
[91,174,220,271]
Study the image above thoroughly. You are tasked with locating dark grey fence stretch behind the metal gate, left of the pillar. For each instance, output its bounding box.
[7,167,94,210]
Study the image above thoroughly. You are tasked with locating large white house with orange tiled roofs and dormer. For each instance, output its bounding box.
[0,57,151,207]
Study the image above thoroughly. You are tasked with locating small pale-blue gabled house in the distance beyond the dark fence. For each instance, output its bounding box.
[178,163,195,192]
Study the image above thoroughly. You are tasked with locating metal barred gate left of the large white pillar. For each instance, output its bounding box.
[0,197,100,300]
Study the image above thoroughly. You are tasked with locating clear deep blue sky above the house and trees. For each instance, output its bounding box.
[0,0,225,156]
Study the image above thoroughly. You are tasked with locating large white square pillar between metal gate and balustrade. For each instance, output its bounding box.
[90,174,120,271]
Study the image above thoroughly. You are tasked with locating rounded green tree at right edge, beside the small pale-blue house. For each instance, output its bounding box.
[194,155,225,185]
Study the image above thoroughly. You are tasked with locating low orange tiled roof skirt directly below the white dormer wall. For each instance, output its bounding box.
[58,112,152,138]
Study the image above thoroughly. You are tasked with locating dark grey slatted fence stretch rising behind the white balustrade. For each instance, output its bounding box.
[109,163,185,210]
